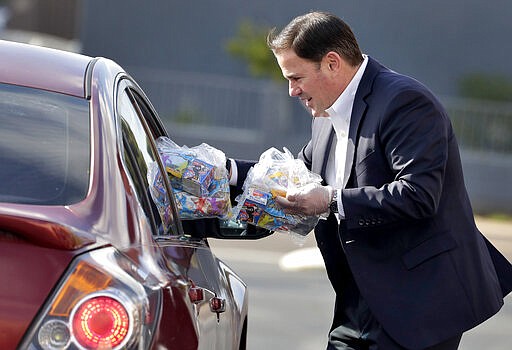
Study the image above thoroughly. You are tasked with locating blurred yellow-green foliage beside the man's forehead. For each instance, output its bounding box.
[226,19,284,81]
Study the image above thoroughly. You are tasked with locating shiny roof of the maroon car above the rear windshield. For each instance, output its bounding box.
[0,40,93,97]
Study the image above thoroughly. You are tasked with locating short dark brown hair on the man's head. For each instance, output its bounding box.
[267,12,363,66]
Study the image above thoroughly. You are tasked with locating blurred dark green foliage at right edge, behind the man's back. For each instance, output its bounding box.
[459,73,512,101]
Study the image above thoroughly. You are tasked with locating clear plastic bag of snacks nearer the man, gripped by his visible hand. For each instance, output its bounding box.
[232,148,322,237]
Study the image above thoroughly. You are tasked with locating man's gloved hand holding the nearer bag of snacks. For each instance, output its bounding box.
[276,183,334,216]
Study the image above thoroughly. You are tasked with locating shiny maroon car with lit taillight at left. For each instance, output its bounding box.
[0,41,269,350]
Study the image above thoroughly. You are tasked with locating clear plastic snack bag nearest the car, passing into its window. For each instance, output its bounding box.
[150,137,232,219]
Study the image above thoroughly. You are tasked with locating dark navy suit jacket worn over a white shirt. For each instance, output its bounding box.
[235,58,512,349]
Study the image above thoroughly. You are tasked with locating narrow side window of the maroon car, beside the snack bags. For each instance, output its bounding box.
[117,80,179,235]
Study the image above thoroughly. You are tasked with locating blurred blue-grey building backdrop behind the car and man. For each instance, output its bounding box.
[0,0,512,214]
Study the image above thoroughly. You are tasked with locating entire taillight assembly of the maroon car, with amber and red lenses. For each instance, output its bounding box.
[20,248,162,350]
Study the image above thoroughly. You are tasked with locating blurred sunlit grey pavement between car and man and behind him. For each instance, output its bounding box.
[210,217,512,350]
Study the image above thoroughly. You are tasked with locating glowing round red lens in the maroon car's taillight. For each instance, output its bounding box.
[73,296,130,349]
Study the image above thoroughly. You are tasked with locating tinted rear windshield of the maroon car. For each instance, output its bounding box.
[0,84,90,205]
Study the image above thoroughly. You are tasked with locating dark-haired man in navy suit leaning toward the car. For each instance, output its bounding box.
[233,12,512,349]
